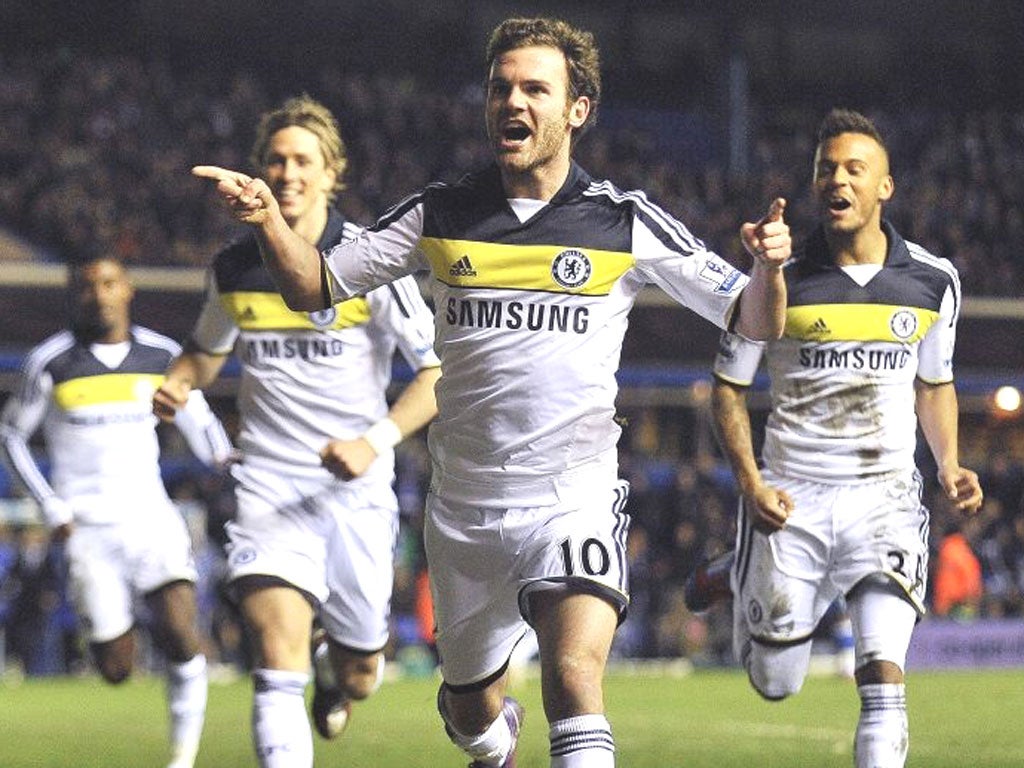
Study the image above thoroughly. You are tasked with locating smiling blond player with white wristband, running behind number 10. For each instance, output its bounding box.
[154,96,440,768]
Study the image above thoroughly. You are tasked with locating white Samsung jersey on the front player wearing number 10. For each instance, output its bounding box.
[326,164,748,507]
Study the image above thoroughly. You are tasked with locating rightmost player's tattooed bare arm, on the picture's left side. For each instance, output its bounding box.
[712,379,794,534]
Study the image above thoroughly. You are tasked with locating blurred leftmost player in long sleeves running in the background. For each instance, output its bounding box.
[0,256,231,768]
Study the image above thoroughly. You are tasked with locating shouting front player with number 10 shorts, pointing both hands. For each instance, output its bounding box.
[195,18,790,768]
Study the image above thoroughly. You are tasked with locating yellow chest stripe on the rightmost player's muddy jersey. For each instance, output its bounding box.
[785,304,939,344]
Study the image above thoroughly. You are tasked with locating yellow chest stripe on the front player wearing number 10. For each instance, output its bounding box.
[420,238,634,296]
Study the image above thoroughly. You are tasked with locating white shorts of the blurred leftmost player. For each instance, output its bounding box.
[68,499,197,643]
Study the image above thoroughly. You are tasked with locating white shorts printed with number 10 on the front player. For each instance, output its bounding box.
[424,479,629,687]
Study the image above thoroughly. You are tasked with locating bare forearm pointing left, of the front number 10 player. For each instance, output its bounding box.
[193,165,327,311]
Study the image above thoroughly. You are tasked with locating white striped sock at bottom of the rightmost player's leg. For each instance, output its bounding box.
[854,683,909,768]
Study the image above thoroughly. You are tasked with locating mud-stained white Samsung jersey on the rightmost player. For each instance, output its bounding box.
[715,223,961,483]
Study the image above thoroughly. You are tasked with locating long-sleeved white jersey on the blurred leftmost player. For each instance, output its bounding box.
[0,326,231,524]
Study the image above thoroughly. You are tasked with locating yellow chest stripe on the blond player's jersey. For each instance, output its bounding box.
[220,291,370,331]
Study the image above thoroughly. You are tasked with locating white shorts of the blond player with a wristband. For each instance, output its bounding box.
[226,465,398,652]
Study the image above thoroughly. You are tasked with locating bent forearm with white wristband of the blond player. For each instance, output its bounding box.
[321,367,441,480]
